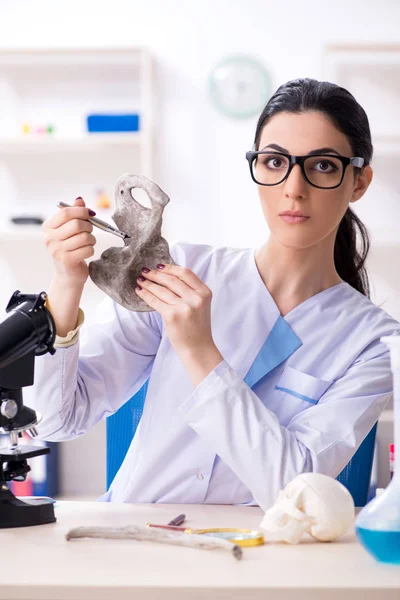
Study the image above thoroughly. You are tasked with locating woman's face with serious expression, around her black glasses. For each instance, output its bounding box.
[258,111,372,249]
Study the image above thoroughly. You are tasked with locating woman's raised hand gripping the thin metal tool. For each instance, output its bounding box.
[42,198,96,285]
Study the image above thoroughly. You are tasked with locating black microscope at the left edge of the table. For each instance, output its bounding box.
[0,290,56,528]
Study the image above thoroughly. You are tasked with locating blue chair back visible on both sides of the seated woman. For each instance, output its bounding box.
[106,381,378,506]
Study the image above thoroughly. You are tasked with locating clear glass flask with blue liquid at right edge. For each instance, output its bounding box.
[355,335,400,565]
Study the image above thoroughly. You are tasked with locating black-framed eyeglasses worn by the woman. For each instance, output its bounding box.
[246,150,364,190]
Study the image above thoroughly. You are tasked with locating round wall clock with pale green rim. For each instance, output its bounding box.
[209,55,271,118]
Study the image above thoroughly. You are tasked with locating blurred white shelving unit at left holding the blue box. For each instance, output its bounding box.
[0,48,156,499]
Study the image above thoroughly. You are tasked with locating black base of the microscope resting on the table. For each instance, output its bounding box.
[0,484,56,529]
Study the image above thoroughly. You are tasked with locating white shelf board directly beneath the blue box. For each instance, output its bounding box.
[0,131,143,155]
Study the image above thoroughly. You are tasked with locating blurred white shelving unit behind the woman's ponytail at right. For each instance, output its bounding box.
[324,45,400,487]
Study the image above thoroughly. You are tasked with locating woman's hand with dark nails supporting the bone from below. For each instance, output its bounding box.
[136,264,216,354]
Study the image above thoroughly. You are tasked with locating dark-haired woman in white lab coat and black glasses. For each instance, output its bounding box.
[33,79,398,509]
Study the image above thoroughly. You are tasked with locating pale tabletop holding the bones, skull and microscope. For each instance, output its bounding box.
[0,501,400,600]
